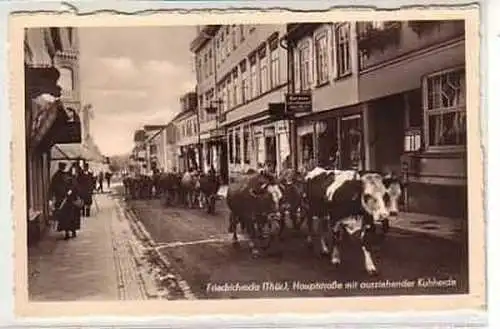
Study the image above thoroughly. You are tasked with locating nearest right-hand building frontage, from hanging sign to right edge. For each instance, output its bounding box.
[286,21,467,217]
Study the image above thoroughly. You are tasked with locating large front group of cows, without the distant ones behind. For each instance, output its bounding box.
[227,167,402,275]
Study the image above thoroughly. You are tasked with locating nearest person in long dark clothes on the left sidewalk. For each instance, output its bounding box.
[50,160,83,240]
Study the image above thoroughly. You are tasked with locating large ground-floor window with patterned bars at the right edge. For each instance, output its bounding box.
[423,68,467,149]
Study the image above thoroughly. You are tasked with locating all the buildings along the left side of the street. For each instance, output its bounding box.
[24,27,106,243]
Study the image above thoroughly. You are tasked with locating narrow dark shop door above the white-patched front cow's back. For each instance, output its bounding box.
[340,114,364,170]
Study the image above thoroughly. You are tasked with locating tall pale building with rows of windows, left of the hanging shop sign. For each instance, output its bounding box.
[191,25,290,182]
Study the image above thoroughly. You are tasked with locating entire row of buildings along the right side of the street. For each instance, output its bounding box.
[134,20,467,217]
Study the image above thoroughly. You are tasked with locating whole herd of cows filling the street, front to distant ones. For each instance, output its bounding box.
[123,167,402,275]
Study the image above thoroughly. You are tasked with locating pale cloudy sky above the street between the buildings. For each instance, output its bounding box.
[78,26,196,156]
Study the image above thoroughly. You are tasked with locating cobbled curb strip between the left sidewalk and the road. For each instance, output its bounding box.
[119,196,197,300]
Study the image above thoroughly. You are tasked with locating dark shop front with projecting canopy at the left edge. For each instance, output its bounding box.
[25,66,81,244]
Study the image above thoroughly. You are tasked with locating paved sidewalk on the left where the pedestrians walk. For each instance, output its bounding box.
[28,193,145,301]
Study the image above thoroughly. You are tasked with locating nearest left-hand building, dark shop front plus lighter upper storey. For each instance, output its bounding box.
[24,28,81,242]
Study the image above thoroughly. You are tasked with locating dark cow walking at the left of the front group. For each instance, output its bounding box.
[226,172,283,256]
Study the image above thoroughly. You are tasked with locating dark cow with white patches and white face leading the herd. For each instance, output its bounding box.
[305,167,401,275]
